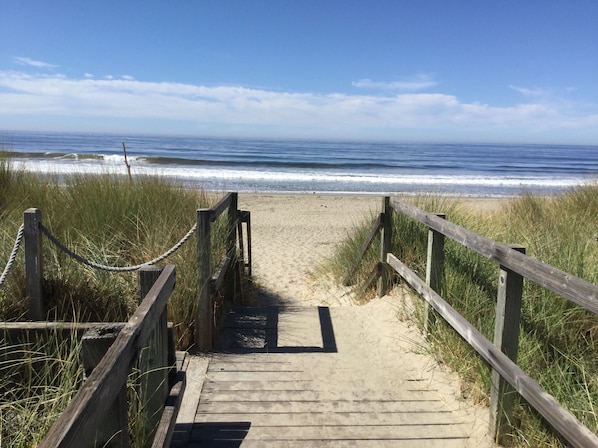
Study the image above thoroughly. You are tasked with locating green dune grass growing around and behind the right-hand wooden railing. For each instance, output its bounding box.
[329,185,598,447]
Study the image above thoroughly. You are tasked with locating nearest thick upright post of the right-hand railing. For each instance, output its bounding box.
[490,246,525,444]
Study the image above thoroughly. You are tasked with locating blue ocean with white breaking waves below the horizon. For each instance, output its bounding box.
[0,131,598,197]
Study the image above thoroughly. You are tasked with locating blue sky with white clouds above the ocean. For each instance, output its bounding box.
[0,0,598,145]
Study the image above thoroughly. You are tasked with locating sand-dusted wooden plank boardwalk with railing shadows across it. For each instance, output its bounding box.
[171,304,489,448]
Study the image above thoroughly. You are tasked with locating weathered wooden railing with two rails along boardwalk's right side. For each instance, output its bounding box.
[352,197,598,447]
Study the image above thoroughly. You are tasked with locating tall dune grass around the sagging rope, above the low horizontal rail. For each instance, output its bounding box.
[0,166,229,347]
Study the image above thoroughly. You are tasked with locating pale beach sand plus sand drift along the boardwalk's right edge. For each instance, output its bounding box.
[234,194,505,446]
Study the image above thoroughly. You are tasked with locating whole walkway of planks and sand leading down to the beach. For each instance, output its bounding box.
[172,195,491,448]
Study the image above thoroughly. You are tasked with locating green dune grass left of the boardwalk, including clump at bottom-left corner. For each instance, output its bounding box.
[0,153,234,447]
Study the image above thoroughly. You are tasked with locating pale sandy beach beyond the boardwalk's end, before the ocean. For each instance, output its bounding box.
[239,194,508,305]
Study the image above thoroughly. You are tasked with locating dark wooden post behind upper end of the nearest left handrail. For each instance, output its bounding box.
[139,266,170,446]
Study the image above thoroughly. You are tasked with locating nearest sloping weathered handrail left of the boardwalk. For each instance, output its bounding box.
[38,265,175,448]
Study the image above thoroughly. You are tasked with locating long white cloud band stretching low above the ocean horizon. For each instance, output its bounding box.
[0,71,598,143]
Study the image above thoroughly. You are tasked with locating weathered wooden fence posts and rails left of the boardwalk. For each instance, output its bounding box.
[0,193,251,448]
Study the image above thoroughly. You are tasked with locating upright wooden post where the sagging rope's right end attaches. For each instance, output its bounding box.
[195,208,214,351]
